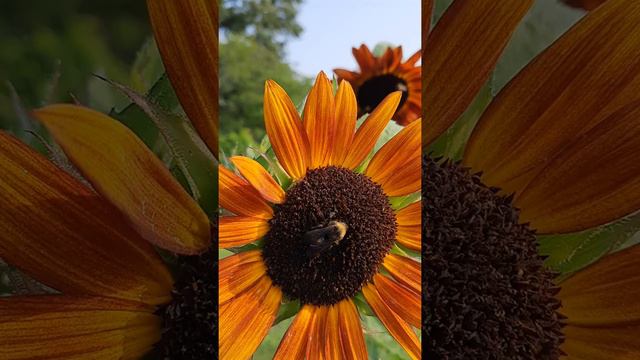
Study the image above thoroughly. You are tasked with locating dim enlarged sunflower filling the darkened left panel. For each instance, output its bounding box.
[0,0,217,359]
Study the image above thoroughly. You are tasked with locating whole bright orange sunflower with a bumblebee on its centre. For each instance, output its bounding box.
[219,73,421,359]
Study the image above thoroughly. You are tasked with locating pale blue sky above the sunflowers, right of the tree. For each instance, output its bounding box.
[287,0,420,77]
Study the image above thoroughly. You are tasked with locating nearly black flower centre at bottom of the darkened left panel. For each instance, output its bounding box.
[158,238,218,359]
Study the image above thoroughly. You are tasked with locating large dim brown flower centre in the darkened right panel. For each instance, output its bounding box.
[422,156,563,360]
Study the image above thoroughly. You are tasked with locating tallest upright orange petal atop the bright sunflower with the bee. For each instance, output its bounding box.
[302,72,338,169]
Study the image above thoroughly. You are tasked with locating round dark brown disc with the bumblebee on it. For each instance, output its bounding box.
[263,167,396,305]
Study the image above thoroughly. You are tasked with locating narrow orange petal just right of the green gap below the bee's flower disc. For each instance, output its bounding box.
[273,305,316,360]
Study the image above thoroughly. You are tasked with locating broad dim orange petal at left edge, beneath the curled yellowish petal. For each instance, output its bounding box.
[0,132,173,305]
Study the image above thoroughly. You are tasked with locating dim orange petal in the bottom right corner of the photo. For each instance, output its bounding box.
[558,246,640,360]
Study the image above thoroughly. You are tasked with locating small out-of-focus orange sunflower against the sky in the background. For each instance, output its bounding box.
[333,44,422,125]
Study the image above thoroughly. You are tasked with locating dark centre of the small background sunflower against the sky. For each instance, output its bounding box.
[356,74,409,116]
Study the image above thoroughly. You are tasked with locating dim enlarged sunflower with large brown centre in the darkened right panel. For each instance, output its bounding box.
[422,0,640,359]
